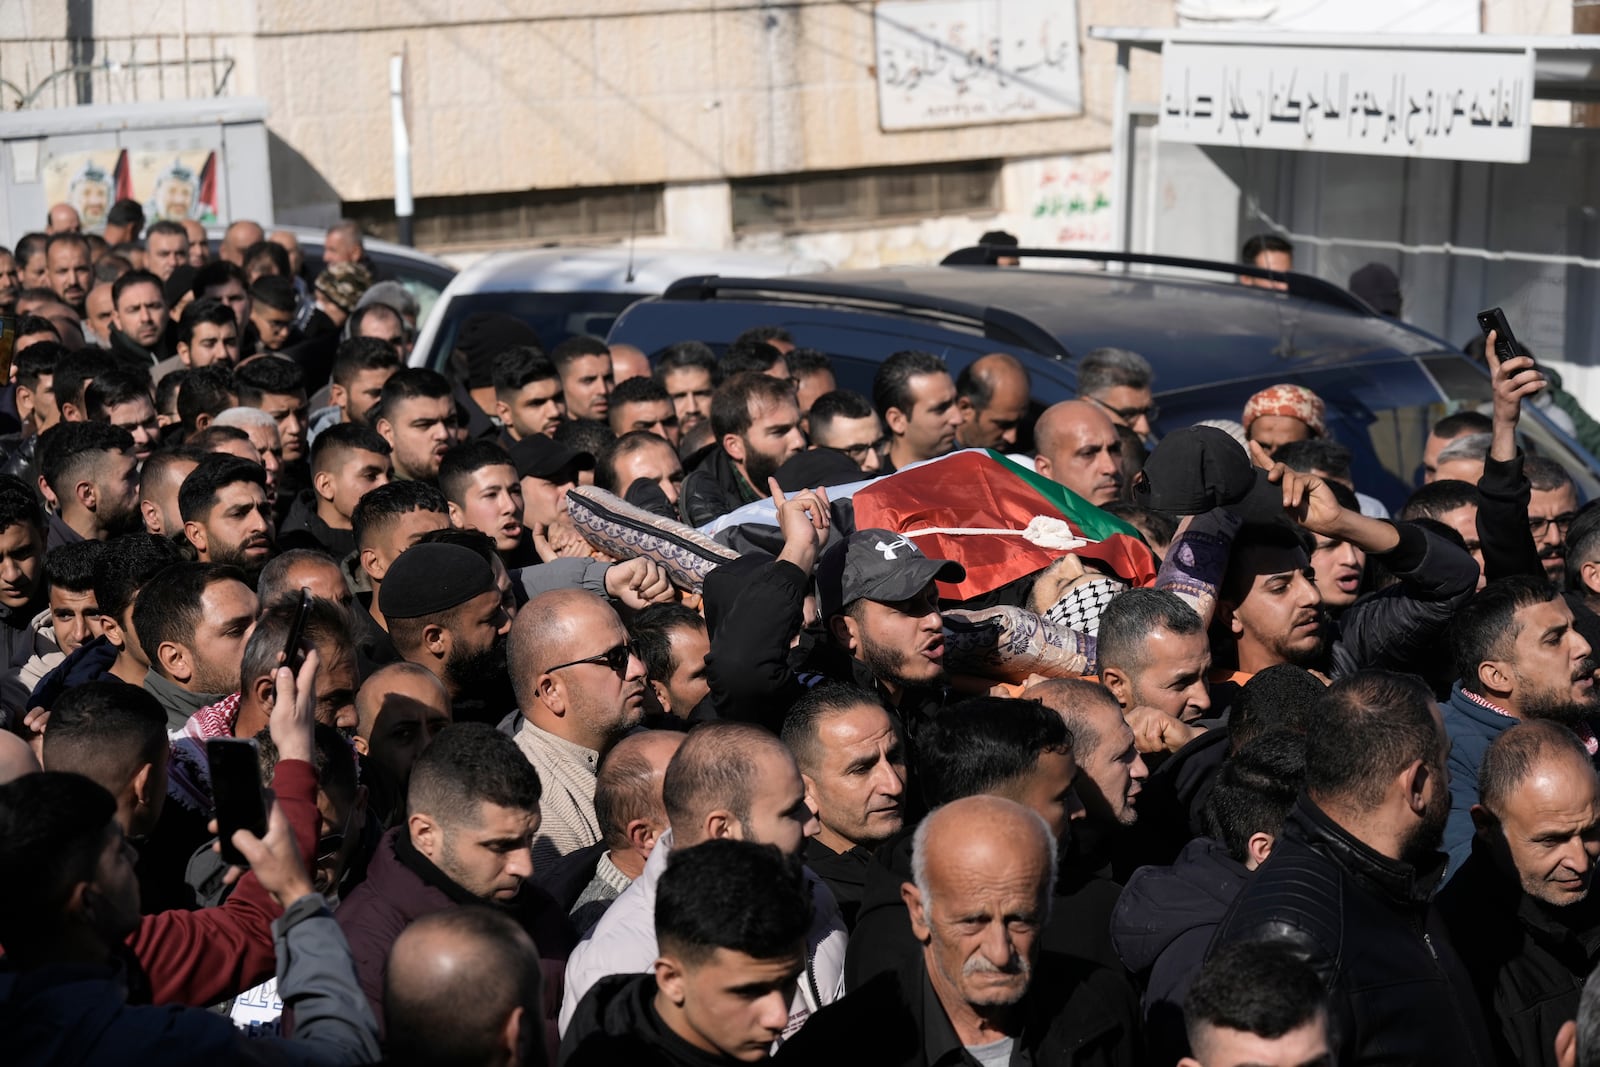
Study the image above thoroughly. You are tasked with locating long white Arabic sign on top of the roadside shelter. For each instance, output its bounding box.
[1160,42,1533,163]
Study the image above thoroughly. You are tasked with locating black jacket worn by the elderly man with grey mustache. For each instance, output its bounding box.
[774,952,1144,1067]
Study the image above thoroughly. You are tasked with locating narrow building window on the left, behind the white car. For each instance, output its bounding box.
[344,186,666,248]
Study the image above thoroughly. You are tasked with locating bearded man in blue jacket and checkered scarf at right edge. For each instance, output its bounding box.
[1443,576,1600,872]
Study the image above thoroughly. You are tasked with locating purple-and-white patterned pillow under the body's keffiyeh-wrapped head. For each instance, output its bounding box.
[944,606,1094,681]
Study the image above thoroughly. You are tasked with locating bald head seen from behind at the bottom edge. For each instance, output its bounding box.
[384,907,544,1067]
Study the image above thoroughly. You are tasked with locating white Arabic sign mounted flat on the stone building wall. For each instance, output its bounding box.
[874,0,1083,131]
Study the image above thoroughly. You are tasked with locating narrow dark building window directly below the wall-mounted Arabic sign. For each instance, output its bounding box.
[728,160,1000,234]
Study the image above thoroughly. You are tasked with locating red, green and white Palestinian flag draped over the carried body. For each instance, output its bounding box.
[851,450,1155,600]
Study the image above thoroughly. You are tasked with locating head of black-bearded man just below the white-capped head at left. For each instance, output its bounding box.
[178,453,277,585]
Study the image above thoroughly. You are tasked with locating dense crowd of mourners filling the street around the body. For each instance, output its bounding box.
[0,202,1600,1067]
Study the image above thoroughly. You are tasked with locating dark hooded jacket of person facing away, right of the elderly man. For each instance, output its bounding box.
[1110,837,1250,1064]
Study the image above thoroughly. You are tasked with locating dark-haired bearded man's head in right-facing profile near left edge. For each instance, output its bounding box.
[38,422,144,549]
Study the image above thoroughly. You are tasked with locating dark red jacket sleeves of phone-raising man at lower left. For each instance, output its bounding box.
[126,760,322,1008]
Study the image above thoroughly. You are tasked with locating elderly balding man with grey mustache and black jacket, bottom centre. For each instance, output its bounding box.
[776,795,1139,1067]
